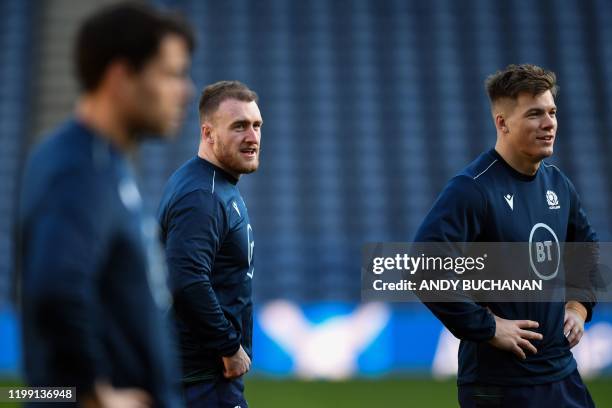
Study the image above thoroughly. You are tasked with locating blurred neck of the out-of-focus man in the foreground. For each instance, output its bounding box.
[76,95,136,153]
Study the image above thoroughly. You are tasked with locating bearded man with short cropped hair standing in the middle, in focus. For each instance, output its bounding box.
[158,81,262,408]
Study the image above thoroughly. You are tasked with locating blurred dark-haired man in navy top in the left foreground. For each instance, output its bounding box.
[17,3,193,407]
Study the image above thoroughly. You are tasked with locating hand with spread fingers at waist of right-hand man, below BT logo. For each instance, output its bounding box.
[489,315,542,360]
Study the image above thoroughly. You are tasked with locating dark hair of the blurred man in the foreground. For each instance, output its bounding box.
[75,2,195,91]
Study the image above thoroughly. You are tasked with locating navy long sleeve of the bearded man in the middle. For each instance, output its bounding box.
[162,190,240,356]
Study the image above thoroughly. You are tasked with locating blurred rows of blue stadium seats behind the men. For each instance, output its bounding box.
[0,0,612,380]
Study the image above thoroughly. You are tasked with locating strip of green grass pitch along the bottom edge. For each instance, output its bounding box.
[0,377,612,408]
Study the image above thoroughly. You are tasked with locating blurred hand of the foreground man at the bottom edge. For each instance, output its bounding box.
[81,382,153,408]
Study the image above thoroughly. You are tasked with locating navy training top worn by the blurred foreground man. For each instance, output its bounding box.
[17,120,182,407]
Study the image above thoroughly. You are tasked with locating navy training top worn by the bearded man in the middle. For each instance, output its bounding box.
[158,156,255,382]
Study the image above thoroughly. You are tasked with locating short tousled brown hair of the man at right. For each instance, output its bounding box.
[485,64,559,103]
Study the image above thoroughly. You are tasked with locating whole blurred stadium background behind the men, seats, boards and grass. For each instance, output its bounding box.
[0,0,612,407]
